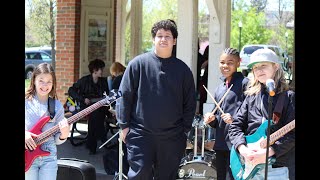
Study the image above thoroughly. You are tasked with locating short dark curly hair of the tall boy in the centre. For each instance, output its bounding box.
[151,19,178,39]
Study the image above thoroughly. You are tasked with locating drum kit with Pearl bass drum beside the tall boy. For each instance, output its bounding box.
[177,115,217,180]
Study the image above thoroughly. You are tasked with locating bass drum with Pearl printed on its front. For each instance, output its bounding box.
[177,152,217,180]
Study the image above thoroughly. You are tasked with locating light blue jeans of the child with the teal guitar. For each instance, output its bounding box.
[252,166,289,180]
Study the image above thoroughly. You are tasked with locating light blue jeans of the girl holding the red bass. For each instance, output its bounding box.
[25,155,58,180]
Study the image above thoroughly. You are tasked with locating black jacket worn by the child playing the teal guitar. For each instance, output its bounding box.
[229,87,295,180]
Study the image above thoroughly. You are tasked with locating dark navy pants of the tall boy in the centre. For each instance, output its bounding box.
[126,130,186,180]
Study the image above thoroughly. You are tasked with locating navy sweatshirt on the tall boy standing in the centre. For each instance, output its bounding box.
[116,52,196,136]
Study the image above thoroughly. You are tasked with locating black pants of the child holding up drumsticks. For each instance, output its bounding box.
[215,150,233,180]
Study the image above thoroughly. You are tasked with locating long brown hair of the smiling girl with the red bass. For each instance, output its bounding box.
[25,63,58,99]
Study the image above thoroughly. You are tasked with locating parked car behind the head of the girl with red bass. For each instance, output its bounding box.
[25,49,52,79]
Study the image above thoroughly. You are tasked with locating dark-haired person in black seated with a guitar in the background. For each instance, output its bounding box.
[68,59,110,154]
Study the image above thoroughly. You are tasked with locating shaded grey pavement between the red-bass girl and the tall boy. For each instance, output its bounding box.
[57,122,120,180]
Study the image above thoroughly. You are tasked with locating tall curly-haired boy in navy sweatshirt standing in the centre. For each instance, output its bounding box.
[116,20,196,180]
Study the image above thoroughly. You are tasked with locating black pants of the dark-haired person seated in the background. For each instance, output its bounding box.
[87,107,107,153]
